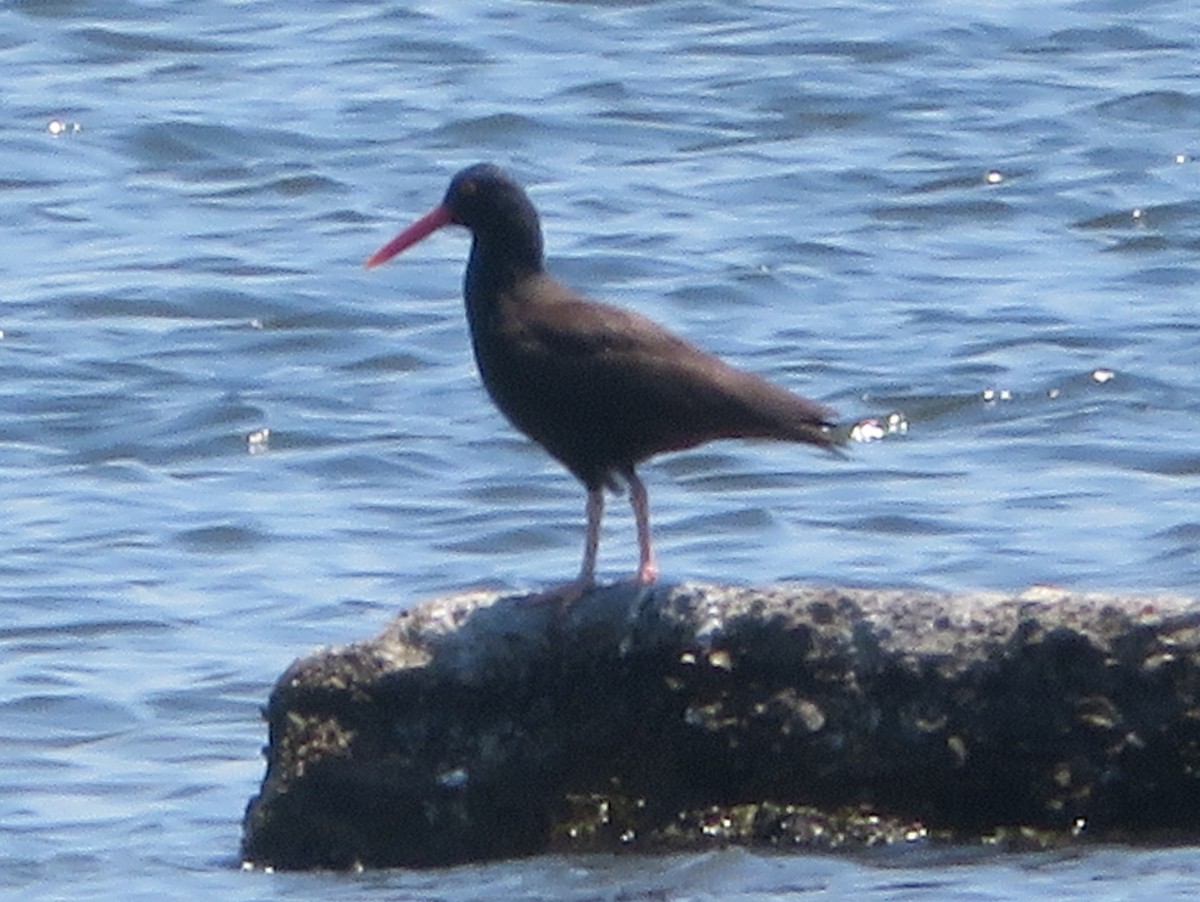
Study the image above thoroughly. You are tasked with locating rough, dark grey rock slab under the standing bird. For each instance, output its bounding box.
[242,585,1200,868]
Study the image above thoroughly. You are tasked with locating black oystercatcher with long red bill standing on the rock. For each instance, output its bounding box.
[366,163,836,602]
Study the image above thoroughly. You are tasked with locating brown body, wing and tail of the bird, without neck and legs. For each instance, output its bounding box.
[480,277,834,485]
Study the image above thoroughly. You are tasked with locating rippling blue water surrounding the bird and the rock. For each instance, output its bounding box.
[7,0,1200,902]
